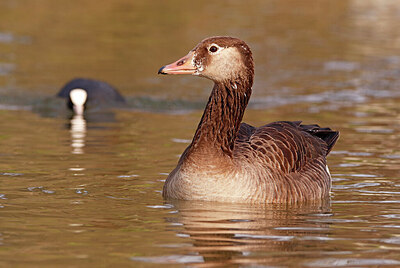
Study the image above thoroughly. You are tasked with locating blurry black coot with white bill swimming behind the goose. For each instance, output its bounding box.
[57,78,125,112]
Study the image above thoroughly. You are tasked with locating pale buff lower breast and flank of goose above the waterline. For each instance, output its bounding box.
[163,163,331,203]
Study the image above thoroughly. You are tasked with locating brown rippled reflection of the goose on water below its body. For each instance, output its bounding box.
[174,199,330,265]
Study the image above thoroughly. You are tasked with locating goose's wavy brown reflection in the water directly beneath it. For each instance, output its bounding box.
[132,201,333,267]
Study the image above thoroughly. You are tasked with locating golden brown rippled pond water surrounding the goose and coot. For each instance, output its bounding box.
[0,0,400,267]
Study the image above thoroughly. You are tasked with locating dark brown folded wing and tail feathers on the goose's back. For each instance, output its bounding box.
[235,121,339,173]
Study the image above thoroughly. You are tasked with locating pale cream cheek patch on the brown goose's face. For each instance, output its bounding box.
[196,44,245,82]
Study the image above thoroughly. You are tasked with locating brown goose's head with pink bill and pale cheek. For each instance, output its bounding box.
[158,36,254,83]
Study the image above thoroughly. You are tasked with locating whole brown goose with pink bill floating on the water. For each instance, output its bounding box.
[158,37,339,203]
